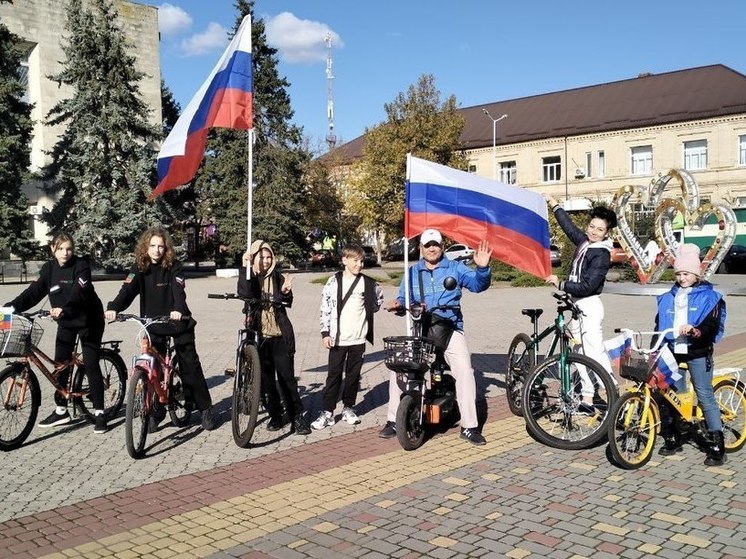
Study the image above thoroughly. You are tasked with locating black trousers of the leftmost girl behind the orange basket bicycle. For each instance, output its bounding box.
[54,319,104,410]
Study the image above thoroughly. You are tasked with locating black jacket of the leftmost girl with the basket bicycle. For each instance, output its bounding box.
[6,256,104,329]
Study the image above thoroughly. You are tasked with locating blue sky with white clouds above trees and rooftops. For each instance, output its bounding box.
[154,0,746,153]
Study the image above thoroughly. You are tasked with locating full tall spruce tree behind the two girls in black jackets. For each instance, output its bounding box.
[45,0,167,267]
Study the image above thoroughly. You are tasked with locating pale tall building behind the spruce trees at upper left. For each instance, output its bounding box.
[0,0,161,242]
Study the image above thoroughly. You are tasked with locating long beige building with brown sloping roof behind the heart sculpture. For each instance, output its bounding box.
[338,64,746,212]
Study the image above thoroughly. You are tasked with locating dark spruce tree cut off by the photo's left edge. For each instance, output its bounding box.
[0,0,36,258]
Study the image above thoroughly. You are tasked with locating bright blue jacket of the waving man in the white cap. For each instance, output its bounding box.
[397,257,492,331]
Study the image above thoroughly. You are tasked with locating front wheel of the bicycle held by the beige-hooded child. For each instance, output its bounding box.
[231,344,262,448]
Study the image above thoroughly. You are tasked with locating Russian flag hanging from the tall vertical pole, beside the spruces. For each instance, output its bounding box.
[150,16,253,199]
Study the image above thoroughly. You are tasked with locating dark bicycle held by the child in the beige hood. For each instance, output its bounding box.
[207,293,262,448]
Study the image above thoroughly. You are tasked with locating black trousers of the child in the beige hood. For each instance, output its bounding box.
[259,336,303,419]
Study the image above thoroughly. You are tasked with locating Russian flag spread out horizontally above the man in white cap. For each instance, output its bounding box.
[404,156,552,279]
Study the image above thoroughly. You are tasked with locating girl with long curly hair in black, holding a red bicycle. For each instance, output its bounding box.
[106,227,217,432]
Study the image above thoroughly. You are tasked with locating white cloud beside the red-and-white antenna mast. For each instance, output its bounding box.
[265,12,344,63]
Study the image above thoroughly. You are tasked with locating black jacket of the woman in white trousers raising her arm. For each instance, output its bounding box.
[554,207,612,299]
